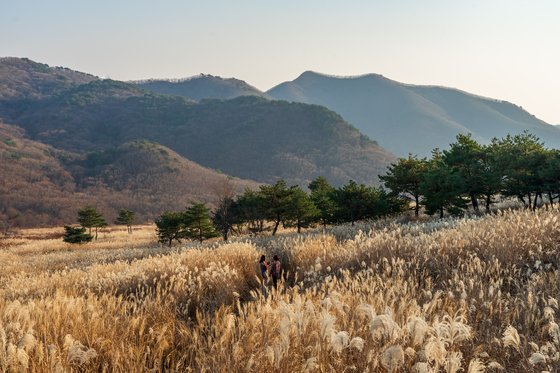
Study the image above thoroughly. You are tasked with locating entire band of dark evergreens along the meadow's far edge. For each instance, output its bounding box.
[65,133,560,246]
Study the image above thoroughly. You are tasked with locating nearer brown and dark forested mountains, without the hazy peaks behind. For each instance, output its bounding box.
[0,58,395,225]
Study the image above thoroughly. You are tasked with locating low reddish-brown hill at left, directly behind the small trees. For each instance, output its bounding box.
[0,123,258,226]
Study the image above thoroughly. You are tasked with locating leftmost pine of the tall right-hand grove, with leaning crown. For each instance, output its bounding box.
[379,154,428,216]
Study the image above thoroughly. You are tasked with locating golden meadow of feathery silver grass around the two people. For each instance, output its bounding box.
[0,210,560,373]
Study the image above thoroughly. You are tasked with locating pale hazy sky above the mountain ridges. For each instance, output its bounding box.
[0,0,560,124]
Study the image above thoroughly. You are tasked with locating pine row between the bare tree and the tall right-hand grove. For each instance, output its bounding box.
[213,177,403,239]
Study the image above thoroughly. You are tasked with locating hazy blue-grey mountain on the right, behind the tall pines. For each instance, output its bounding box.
[267,71,560,156]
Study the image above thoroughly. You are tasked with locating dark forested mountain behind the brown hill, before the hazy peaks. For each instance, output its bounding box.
[0,73,394,185]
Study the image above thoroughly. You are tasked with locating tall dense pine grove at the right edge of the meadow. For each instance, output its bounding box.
[380,132,560,217]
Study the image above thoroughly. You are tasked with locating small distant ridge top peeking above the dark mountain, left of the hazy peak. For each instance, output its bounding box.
[134,75,267,101]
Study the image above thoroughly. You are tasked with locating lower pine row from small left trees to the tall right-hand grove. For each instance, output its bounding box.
[155,177,404,245]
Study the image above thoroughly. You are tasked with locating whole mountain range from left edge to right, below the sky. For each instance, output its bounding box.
[0,58,560,225]
